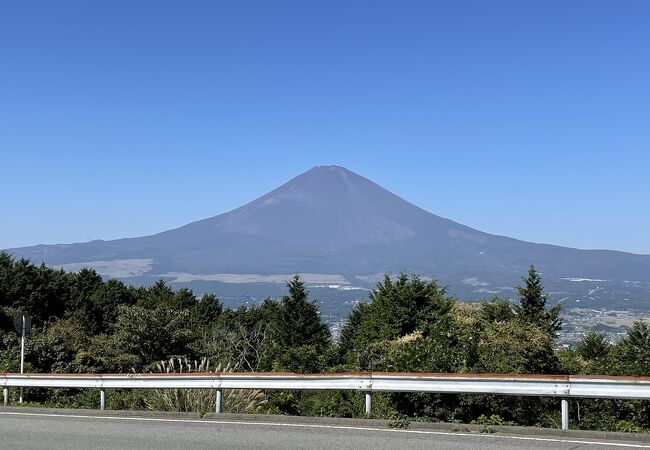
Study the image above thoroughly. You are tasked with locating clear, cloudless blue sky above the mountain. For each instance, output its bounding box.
[0,0,650,254]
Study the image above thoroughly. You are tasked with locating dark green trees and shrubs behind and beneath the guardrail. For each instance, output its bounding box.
[0,253,650,431]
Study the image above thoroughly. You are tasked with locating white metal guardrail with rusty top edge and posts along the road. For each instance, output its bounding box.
[0,372,650,429]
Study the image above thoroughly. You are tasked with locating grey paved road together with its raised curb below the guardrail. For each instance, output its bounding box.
[0,408,650,450]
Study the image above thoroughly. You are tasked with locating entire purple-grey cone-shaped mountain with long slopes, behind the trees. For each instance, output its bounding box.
[8,166,650,308]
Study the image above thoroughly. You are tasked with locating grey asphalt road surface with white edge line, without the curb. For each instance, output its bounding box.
[0,410,650,450]
